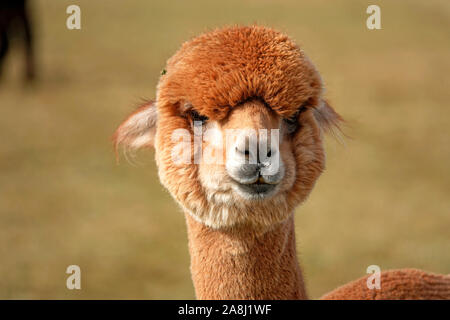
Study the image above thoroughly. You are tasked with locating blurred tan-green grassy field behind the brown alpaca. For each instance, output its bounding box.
[0,0,450,299]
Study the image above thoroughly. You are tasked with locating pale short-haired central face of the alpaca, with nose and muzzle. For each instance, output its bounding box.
[198,100,296,201]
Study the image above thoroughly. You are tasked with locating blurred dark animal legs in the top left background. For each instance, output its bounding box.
[0,0,35,81]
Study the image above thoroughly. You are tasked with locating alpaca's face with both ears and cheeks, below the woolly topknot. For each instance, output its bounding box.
[115,99,338,230]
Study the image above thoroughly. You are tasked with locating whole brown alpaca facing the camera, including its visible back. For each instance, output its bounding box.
[114,26,450,299]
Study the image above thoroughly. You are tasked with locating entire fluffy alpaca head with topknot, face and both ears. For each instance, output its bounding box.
[115,26,340,229]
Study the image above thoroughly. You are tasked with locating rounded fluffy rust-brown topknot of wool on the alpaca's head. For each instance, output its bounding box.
[157,26,322,120]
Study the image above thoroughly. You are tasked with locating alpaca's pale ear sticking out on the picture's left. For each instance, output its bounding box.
[113,101,158,153]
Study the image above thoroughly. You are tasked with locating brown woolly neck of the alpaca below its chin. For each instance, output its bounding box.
[186,214,306,299]
